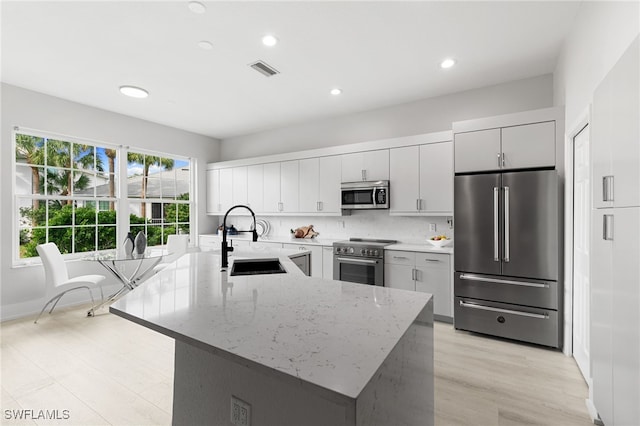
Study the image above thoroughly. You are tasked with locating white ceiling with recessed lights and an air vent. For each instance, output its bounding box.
[1,0,579,138]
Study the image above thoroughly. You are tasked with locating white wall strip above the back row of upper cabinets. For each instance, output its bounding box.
[220,74,553,160]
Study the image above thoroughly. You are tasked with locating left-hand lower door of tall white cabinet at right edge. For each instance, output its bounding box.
[589,209,616,425]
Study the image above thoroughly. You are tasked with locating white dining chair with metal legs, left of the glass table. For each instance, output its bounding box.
[34,243,105,324]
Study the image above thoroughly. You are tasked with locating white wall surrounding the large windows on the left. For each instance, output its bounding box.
[0,84,220,320]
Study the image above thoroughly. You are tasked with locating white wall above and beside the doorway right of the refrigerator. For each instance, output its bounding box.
[554,1,640,360]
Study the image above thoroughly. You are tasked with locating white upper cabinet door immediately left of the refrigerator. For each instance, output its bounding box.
[420,142,453,215]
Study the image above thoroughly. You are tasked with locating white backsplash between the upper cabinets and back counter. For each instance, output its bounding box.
[220,210,453,244]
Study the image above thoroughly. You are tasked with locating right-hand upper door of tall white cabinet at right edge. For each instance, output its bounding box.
[601,38,640,207]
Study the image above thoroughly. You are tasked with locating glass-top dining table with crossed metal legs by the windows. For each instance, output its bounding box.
[83,249,165,316]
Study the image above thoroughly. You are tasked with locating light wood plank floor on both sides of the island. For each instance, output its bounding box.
[0,307,590,426]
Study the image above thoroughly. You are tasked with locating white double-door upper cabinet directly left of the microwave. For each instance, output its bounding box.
[299,155,341,214]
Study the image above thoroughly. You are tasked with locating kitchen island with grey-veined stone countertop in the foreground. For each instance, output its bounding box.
[110,249,434,426]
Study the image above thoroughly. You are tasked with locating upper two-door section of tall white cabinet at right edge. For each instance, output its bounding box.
[591,35,640,208]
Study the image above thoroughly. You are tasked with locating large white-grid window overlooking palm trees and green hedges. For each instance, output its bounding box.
[13,129,193,262]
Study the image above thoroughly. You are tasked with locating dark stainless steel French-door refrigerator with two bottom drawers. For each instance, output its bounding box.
[454,170,562,347]
